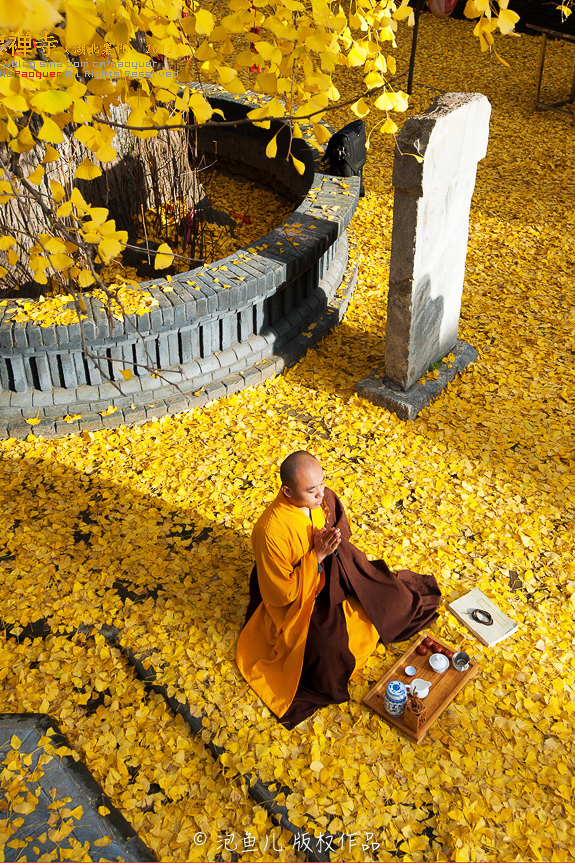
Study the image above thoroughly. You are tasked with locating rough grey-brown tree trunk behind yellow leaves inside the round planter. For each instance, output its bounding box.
[0,100,202,297]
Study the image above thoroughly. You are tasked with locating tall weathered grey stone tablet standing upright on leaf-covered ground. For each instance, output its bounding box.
[385,93,491,391]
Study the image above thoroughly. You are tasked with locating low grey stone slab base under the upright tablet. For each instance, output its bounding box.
[355,339,477,420]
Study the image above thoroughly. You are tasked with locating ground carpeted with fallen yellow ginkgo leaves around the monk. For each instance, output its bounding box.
[0,16,575,861]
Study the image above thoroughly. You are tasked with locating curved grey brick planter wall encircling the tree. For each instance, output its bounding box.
[0,92,359,437]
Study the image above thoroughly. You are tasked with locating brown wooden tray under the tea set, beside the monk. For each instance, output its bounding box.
[363,632,479,743]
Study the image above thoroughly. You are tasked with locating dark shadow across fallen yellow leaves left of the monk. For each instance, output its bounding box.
[0,454,252,679]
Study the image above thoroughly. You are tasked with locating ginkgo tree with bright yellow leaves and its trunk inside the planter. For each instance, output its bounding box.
[0,0,517,309]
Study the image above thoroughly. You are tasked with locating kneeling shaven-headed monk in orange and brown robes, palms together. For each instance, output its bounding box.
[236,450,441,728]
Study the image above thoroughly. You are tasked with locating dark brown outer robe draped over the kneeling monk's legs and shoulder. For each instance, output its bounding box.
[245,488,441,728]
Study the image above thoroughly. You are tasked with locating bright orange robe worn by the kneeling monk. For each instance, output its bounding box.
[236,491,379,717]
